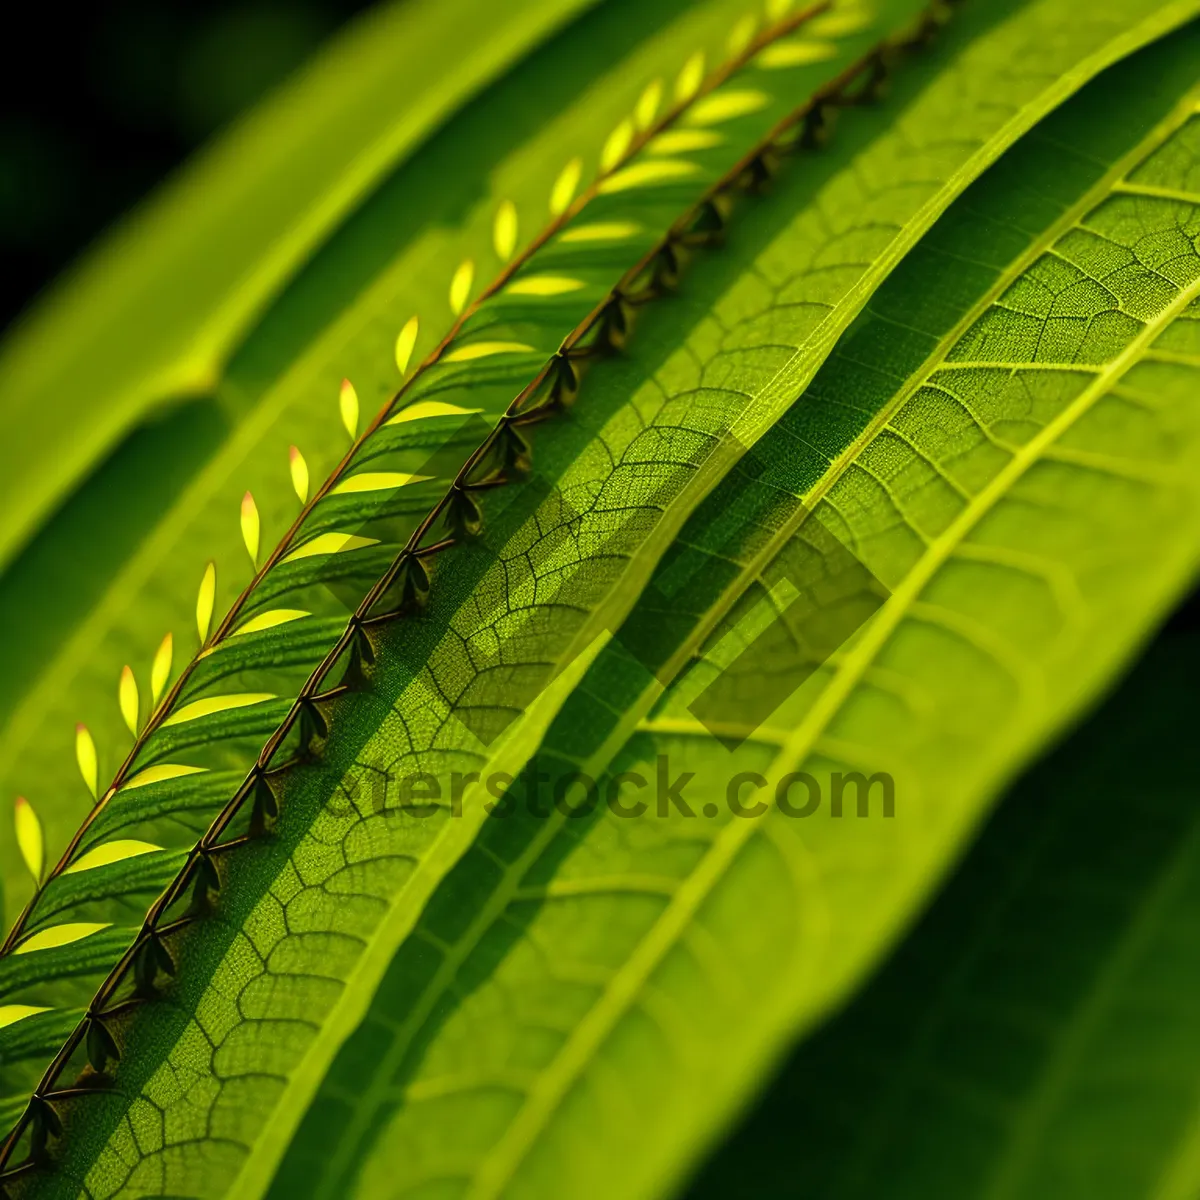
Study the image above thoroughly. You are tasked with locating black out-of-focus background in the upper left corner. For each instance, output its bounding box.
[0,0,368,329]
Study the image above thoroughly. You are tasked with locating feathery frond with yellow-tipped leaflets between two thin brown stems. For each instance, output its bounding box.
[2,2,931,1171]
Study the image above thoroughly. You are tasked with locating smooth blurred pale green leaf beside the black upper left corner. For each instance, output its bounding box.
[0,0,595,576]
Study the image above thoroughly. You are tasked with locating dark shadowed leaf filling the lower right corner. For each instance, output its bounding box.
[688,628,1200,1200]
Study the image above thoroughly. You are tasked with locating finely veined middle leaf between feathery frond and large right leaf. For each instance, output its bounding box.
[14,4,1190,1194]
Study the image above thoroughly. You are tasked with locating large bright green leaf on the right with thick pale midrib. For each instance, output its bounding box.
[262,16,1200,1196]
